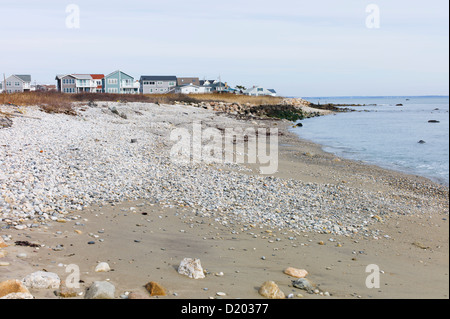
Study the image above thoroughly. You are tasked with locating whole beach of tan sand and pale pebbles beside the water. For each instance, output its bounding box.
[0,102,449,302]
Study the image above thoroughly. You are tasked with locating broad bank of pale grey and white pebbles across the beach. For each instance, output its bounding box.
[0,103,446,236]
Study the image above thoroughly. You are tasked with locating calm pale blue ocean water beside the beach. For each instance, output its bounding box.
[294,96,449,185]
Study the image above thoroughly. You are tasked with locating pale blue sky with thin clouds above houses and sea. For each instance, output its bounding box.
[0,0,449,97]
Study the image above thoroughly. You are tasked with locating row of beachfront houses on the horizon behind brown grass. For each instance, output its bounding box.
[0,70,277,96]
